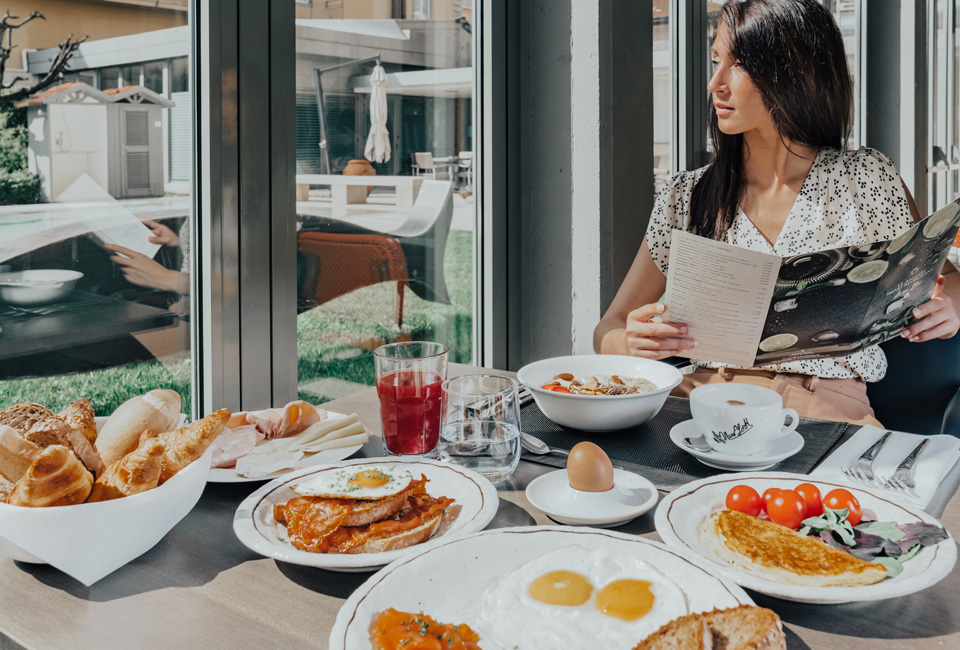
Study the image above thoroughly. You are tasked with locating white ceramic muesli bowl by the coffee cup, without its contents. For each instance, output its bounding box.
[517,354,683,431]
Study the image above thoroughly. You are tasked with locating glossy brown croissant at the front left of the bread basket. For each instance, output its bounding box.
[7,445,93,508]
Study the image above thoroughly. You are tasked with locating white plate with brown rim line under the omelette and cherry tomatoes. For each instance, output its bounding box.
[655,472,957,604]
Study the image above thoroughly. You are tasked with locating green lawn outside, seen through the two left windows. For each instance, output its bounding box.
[0,231,473,414]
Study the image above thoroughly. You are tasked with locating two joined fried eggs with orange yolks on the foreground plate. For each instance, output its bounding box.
[475,546,689,650]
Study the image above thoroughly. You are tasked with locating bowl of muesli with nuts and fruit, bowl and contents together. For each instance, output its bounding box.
[517,354,683,431]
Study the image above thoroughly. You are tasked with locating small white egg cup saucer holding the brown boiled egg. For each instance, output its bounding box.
[527,469,660,528]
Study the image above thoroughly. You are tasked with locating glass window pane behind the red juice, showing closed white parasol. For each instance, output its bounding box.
[296,0,476,403]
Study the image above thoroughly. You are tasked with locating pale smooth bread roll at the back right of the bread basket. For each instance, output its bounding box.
[97,388,180,465]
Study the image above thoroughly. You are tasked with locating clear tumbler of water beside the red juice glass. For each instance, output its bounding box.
[439,375,520,483]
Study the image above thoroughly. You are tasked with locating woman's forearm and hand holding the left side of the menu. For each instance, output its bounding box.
[593,238,695,359]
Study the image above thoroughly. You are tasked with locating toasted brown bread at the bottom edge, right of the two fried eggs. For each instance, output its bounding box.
[634,605,787,650]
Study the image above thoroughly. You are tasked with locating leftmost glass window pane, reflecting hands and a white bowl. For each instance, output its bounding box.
[0,5,193,415]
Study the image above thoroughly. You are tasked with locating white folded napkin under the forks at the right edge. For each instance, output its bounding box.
[810,424,960,509]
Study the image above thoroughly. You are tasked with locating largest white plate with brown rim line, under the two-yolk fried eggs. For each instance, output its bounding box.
[330,526,753,650]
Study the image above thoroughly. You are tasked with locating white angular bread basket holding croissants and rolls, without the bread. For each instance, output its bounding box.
[0,418,213,586]
